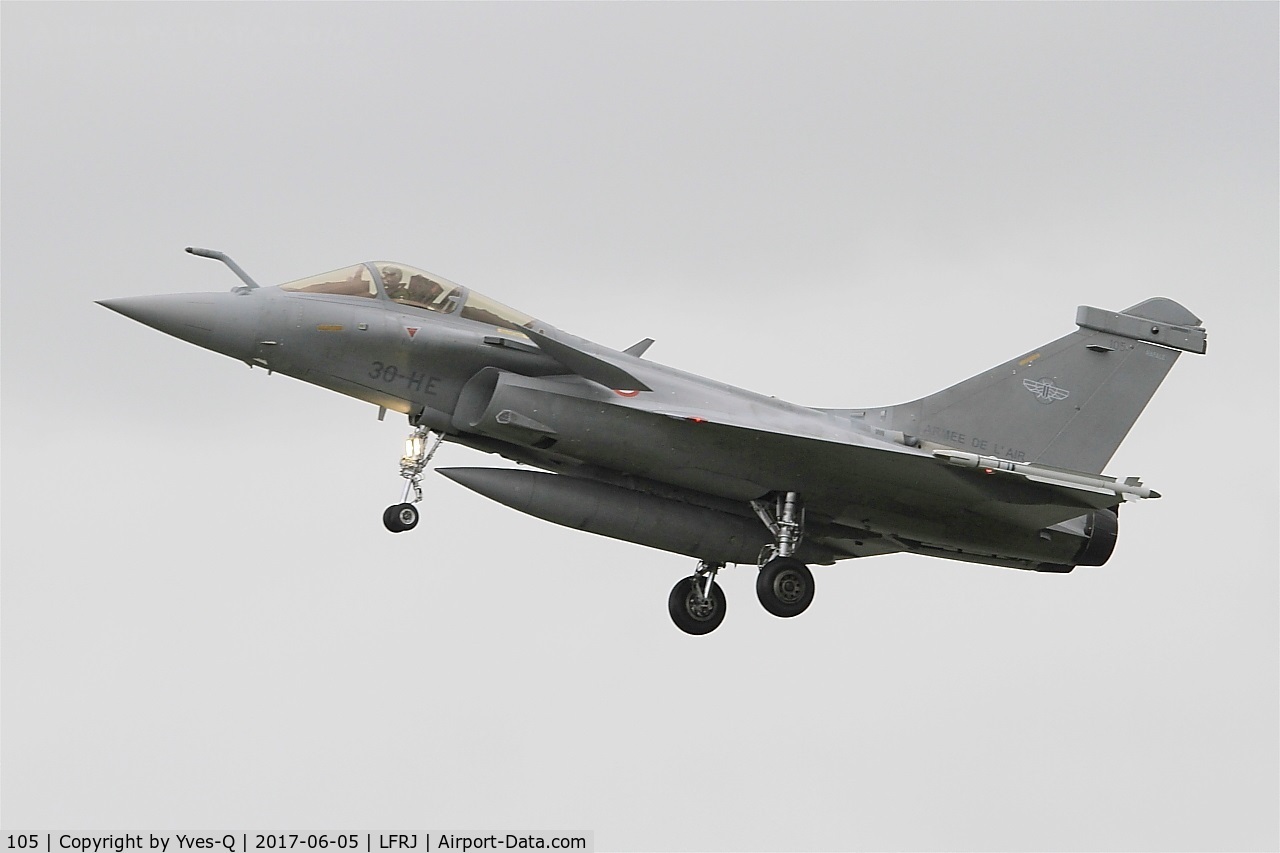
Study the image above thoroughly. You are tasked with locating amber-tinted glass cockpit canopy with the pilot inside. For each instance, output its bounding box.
[280,261,534,330]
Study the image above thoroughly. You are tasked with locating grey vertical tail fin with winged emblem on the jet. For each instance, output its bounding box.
[885,297,1207,474]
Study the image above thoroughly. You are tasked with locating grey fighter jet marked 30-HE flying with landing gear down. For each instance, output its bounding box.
[100,248,1207,634]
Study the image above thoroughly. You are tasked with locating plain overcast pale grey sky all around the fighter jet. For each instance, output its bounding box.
[0,3,1280,850]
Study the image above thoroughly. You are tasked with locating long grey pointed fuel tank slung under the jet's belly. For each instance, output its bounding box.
[436,467,829,565]
